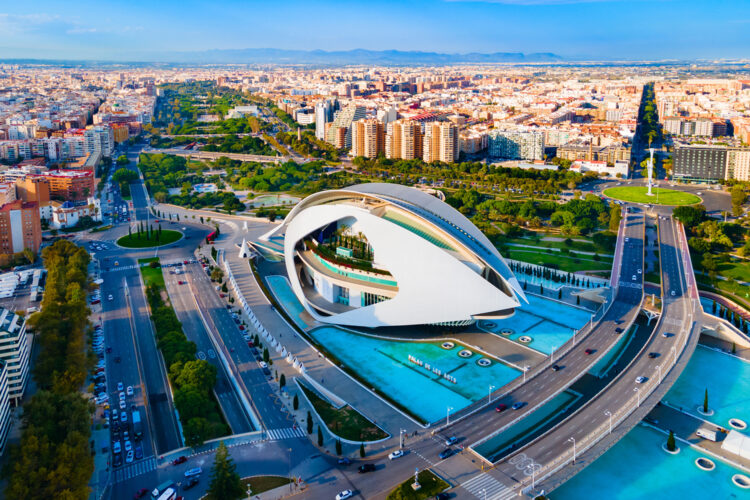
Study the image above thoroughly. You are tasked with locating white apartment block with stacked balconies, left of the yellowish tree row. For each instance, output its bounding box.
[0,308,32,406]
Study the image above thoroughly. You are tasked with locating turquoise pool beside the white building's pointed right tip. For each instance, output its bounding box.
[481,295,591,354]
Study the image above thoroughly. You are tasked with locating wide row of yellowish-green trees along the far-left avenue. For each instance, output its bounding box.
[4,240,94,500]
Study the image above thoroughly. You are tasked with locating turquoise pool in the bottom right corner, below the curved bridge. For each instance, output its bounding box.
[550,425,748,500]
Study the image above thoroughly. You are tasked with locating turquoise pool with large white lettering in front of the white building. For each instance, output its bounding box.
[310,326,519,422]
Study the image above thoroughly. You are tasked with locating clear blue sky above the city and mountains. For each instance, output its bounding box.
[0,0,750,60]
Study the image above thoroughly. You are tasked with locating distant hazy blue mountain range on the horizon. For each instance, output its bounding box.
[163,49,563,65]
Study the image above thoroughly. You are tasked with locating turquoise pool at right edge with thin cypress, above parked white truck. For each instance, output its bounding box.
[664,345,750,427]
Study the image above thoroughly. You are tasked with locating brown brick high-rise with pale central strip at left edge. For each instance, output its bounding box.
[0,200,42,260]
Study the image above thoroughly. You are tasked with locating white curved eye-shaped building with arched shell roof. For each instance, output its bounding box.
[261,183,526,328]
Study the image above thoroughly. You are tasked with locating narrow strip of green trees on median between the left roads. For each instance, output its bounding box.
[146,284,229,447]
